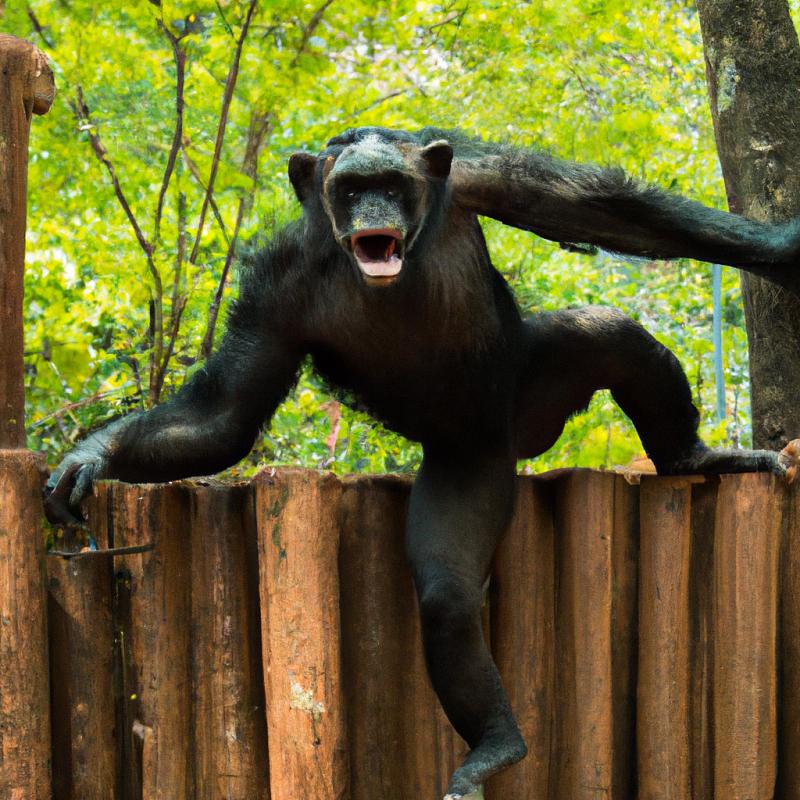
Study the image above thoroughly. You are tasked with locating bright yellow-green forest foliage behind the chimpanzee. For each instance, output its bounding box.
[6,0,800,474]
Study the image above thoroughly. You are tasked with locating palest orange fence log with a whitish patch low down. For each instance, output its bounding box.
[256,471,348,800]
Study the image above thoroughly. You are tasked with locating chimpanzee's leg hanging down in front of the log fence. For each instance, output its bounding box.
[406,449,527,799]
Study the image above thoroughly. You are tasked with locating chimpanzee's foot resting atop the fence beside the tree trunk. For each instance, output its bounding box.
[656,439,800,483]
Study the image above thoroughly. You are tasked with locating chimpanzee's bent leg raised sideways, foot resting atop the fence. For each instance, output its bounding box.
[517,307,793,474]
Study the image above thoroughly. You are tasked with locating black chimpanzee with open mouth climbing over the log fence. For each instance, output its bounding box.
[46,128,800,799]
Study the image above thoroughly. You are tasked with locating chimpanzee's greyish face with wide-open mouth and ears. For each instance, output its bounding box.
[289,129,452,286]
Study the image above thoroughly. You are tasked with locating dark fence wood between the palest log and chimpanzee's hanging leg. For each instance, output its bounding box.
[339,478,467,800]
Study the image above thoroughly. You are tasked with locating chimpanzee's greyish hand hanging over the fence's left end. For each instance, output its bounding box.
[44,429,111,525]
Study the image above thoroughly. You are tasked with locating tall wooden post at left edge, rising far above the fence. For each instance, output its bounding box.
[0,34,55,800]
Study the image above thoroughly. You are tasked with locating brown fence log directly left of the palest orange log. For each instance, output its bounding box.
[189,486,269,800]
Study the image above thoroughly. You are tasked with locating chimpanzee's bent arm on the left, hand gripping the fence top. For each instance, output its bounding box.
[45,231,304,523]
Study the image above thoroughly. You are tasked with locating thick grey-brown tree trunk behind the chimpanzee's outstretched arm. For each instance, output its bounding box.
[697,0,800,450]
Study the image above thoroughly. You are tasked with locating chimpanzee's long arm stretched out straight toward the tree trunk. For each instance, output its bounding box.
[444,131,800,294]
